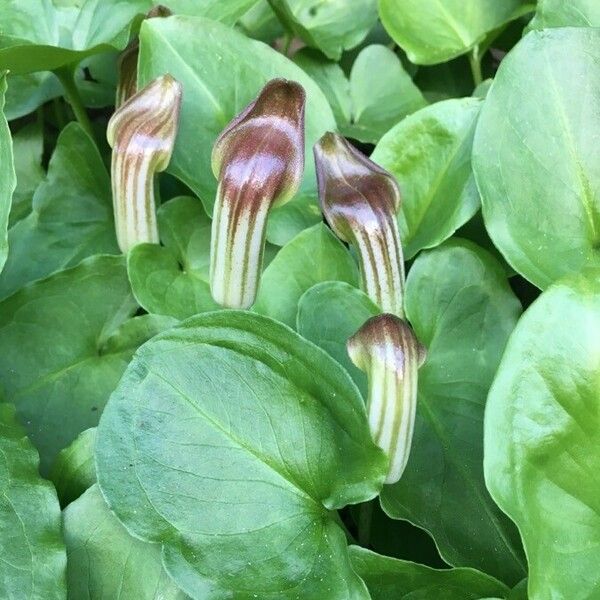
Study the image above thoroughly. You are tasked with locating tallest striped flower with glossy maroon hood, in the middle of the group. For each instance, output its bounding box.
[210,79,305,308]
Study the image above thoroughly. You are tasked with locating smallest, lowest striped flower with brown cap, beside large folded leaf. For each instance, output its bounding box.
[347,314,426,483]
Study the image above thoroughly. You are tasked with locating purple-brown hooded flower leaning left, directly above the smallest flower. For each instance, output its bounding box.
[314,132,404,317]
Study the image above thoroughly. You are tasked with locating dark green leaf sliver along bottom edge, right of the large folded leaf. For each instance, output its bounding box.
[350,546,508,600]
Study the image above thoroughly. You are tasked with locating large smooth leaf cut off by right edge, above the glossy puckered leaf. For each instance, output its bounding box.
[473,28,600,289]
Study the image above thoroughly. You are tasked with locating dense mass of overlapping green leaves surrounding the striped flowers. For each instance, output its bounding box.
[0,0,600,600]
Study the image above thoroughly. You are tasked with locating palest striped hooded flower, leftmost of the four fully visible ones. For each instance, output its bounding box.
[107,75,182,252]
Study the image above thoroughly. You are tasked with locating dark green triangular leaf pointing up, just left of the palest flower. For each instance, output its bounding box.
[0,123,119,298]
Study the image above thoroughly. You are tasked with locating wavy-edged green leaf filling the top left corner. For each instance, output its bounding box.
[0,0,152,75]
